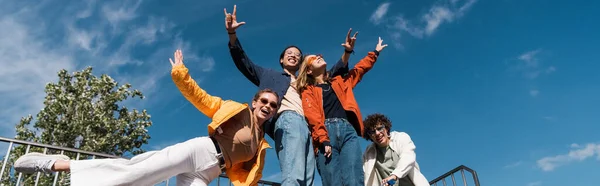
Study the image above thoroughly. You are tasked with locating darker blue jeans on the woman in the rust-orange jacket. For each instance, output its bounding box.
[317,118,365,186]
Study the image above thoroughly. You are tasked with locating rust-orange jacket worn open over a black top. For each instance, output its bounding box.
[301,52,378,153]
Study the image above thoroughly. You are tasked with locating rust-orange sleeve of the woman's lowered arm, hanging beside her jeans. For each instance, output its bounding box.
[300,87,329,147]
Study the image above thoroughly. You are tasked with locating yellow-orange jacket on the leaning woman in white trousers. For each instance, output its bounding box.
[171,65,270,186]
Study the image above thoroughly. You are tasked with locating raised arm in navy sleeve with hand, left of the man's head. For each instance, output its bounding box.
[223,5,265,86]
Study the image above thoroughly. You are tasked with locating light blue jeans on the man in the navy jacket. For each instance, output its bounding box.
[274,111,315,186]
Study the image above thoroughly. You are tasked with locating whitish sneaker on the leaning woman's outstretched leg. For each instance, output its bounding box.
[15,152,70,173]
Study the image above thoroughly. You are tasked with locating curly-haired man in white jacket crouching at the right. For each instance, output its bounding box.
[363,114,429,186]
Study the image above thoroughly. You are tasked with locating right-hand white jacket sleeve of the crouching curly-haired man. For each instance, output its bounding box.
[392,133,417,178]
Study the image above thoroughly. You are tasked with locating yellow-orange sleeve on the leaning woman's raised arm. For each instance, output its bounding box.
[171,64,224,118]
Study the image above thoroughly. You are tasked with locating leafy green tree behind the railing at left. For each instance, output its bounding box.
[1,67,152,185]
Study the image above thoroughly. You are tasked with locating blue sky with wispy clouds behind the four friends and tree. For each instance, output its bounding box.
[0,0,600,186]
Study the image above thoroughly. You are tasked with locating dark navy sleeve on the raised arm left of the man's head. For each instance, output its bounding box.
[227,39,265,86]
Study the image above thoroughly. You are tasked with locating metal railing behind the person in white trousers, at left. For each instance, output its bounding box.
[0,137,281,186]
